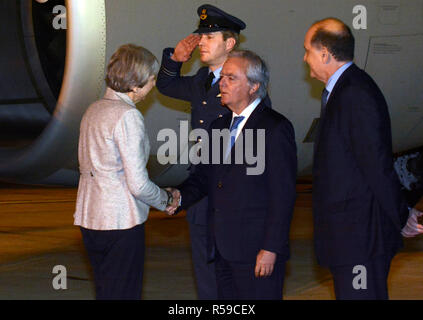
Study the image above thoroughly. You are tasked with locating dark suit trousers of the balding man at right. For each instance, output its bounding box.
[330,256,392,300]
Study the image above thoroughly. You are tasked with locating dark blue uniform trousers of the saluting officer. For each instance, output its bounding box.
[189,223,217,300]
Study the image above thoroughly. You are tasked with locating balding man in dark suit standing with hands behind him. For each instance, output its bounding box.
[304,18,416,299]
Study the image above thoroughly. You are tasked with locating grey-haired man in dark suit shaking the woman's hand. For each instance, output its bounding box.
[171,51,297,299]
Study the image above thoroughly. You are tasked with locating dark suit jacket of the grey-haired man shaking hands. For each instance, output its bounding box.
[180,102,297,263]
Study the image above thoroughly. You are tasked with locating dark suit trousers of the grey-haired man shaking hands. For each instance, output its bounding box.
[216,252,285,300]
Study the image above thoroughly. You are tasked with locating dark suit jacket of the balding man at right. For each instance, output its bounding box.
[313,64,408,266]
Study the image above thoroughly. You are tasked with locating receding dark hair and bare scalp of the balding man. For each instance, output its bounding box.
[311,18,355,61]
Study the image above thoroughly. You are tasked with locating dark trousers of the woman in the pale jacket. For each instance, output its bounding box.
[81,224,145,300]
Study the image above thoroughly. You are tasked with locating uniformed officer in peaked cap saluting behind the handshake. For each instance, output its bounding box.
[156,4,246,299]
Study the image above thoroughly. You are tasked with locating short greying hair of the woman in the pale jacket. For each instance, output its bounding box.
[105,44,159,92]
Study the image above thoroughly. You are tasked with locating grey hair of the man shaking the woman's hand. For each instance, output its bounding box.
[228,50,269,99]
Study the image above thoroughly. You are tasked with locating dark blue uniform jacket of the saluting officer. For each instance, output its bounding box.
[156,48,271,225]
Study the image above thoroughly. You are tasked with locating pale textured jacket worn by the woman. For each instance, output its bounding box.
[74,88,167,230]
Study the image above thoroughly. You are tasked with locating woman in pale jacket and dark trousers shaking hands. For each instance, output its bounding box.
[74,44,177,300]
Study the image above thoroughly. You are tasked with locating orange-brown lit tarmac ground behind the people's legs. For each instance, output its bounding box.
[0,183,423,300]
